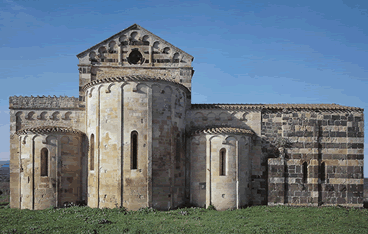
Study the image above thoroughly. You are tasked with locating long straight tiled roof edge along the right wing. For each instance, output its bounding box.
[192,104,364,111]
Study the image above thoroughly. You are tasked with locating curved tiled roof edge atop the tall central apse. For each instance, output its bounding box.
[83,76,188,91]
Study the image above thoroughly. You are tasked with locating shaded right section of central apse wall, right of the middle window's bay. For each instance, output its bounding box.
[152,84,190,209]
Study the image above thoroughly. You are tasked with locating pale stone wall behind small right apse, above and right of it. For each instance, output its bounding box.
[187,104,268,205]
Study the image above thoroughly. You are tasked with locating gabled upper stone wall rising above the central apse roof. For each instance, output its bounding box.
[77,24,194,104]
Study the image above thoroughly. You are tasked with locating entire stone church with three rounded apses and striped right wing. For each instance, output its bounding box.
[9,24,364,210]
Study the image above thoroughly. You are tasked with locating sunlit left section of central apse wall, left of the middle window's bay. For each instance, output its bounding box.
[86,84,123,208]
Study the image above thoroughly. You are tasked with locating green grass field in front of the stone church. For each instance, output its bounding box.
[0,204,368,233]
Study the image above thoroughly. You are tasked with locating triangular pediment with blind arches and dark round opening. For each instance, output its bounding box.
[77,24,193,67]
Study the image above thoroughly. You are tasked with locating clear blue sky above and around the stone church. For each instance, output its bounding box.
[0,0,368,177]
